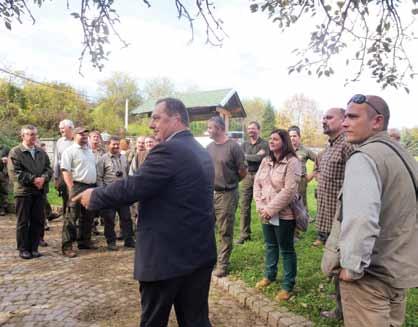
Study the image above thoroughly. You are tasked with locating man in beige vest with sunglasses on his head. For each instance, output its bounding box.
[339,94,418,327]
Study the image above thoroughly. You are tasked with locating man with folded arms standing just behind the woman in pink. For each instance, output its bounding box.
[235,121,269,244]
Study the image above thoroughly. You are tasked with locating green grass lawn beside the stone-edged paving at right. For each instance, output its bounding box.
[231,163,418,327]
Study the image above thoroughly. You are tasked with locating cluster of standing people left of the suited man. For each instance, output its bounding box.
[1,119,157,259]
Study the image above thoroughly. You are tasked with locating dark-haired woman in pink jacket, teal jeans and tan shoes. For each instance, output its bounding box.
[254,129,301,301]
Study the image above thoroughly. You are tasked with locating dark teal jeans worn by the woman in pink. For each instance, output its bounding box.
[262,219,297,292]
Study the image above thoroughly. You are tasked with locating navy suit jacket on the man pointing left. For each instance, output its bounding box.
[89,131,216,281]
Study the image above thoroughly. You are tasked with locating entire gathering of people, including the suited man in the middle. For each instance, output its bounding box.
[1,94,418,327]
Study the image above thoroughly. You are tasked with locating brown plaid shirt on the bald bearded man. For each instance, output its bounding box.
[316,134,353,234]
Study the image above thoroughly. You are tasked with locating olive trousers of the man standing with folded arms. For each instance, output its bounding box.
[240,172,255,239]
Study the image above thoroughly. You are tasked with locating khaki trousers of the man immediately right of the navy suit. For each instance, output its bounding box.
[213,189,238,270]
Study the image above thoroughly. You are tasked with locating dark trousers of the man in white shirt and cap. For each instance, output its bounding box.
[62,183,96,250]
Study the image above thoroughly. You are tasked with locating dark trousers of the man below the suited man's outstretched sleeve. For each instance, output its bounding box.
[100,206,133,243]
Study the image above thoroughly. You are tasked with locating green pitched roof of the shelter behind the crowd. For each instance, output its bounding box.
[131,89,247,120]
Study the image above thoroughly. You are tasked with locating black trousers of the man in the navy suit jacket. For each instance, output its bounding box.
[139,266,213,327]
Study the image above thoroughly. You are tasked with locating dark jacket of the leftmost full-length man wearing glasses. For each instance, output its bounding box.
[7,144,52,197]
